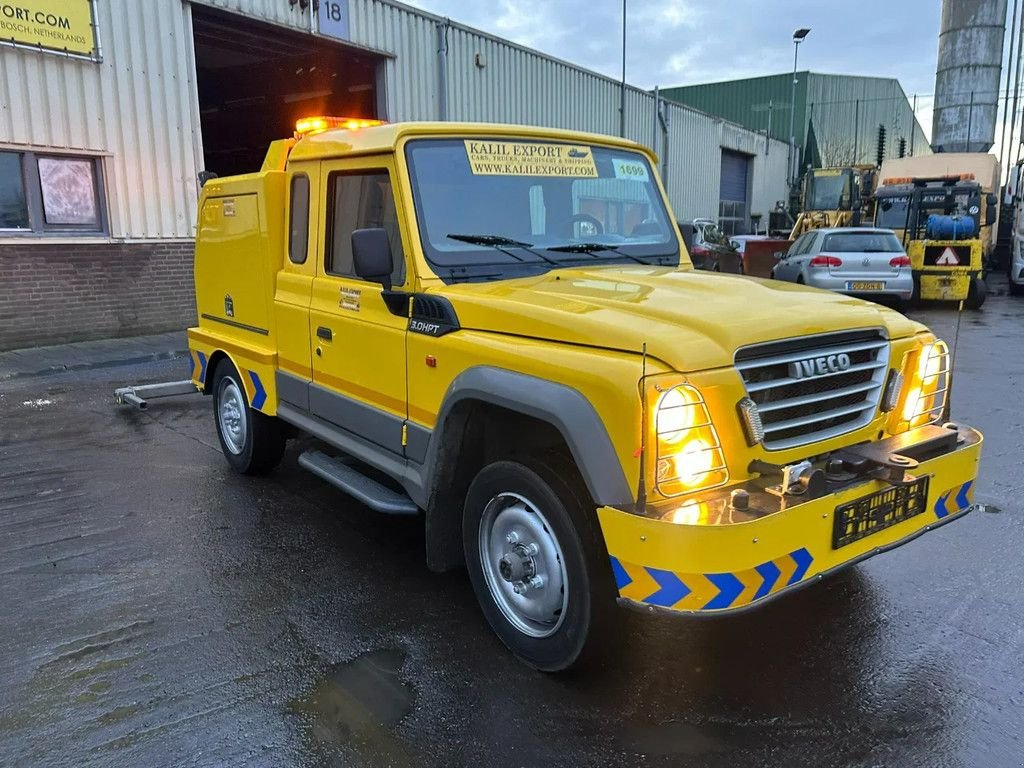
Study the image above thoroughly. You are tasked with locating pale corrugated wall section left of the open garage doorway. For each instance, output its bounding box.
[0,0,196,239]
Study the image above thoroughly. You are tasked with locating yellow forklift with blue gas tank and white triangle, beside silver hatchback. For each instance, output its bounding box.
[874,174,996,309]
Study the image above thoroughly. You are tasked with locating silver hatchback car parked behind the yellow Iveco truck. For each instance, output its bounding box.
[771,226,913,302]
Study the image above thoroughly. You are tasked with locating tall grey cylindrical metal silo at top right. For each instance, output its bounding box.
[932,0,1007,152]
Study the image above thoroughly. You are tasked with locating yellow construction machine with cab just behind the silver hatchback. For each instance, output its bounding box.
[790,165,878,240]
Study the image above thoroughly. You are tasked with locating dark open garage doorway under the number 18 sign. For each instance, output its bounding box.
[191,5,383,176]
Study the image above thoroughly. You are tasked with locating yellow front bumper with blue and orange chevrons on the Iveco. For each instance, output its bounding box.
[598,427,982,614]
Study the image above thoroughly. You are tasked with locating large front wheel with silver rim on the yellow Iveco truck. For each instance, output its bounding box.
[463,461,614,672]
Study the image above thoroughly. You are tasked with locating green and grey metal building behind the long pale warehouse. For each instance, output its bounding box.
[660,71,932,173]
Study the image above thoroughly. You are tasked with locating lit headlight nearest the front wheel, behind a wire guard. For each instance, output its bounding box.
[654,384,729,497]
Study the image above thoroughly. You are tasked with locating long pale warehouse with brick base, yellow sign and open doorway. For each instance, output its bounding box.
[0,0,785,349]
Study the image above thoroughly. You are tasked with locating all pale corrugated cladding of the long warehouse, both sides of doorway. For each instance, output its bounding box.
[0,0,785,239]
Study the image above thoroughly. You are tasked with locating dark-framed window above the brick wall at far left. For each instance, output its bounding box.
[0,150,106,234]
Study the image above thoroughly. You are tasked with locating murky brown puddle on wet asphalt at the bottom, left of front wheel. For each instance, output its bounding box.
[290,649,416,745]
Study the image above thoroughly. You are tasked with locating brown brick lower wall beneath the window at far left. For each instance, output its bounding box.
[0,241,196,350]
